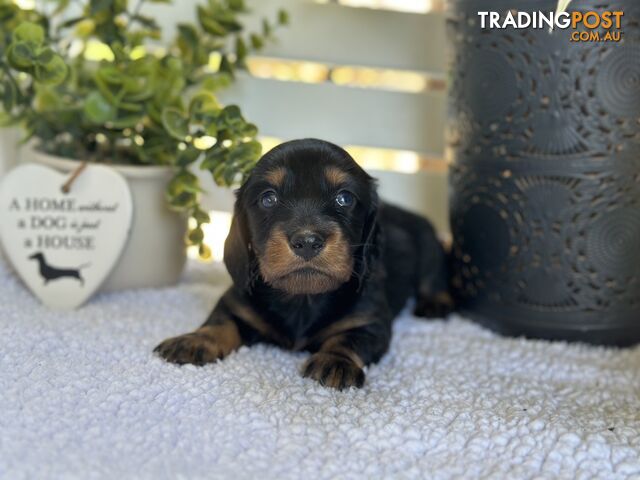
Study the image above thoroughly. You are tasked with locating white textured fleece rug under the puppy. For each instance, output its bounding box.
[0,255,640,479]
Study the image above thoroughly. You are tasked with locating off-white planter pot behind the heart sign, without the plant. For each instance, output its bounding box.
[29,150,187,291]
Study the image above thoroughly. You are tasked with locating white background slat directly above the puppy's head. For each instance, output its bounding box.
[222,75,446,155]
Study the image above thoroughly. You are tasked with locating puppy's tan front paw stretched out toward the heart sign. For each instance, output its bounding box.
[153,326,240,365]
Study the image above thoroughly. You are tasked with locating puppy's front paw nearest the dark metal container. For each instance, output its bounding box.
[302,352,364,390]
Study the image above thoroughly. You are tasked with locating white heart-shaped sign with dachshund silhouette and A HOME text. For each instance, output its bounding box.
[0,164,133,309]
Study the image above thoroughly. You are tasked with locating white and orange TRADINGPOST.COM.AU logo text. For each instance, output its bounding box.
[478,10,624,42]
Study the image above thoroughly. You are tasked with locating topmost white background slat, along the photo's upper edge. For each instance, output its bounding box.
[235,0,446,72]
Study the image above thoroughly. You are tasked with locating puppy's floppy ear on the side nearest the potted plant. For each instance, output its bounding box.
[224,200,253,289]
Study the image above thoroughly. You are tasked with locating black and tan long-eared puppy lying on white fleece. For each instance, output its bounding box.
[155,139,452,389]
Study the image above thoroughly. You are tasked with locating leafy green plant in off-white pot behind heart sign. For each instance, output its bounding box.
[0,0,288,289]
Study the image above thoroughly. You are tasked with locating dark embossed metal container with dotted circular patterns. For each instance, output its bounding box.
[447,0,640,345]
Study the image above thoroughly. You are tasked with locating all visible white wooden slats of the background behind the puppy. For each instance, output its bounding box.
[0,0,448,232]
